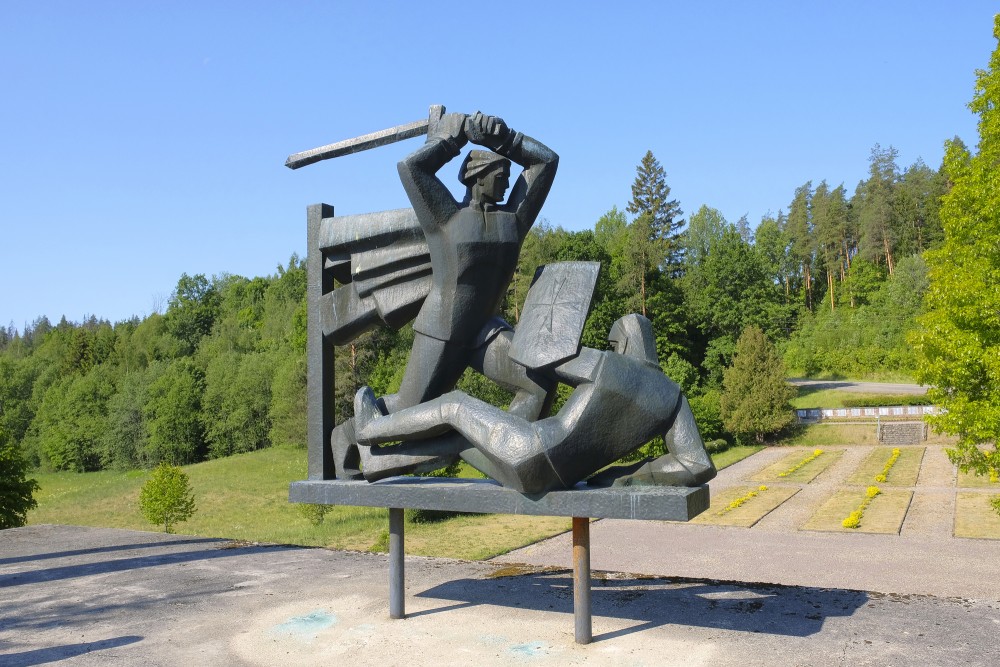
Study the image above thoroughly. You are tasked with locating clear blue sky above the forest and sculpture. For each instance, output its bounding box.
[0,0,1000,329]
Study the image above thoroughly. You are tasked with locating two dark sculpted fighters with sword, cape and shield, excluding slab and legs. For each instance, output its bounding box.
[287,107,715,494]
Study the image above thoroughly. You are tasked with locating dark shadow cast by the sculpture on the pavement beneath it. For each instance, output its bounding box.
[417,570,869,641]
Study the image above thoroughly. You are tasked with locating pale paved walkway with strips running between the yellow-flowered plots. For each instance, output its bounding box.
[495,445,1000,601]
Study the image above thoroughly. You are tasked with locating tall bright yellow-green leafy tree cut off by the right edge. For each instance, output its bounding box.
[914,15,1000,482]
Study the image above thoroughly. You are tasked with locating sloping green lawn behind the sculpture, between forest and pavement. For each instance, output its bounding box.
[28,447,760,559]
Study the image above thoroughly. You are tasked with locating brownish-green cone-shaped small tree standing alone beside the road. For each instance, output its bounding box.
[722,326,795,443]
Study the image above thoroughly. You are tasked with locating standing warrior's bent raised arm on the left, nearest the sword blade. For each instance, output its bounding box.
[397,113,467,231]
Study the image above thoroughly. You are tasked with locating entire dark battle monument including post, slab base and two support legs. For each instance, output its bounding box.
[286,106,715,643]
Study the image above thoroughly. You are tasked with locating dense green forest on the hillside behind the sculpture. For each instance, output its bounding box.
[0,144,948,471]
